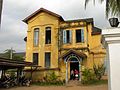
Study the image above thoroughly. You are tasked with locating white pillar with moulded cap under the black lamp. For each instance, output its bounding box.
[102,28,120,90]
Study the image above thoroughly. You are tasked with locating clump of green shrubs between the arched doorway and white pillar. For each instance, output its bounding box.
[82,64,105,84]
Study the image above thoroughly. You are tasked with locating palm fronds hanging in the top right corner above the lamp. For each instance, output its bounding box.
[85,0,120,18]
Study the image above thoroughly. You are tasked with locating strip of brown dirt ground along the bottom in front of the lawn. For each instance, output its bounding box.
[0,84,108,90]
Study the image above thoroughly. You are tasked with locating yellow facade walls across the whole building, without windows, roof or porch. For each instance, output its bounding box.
[26,9,105,79]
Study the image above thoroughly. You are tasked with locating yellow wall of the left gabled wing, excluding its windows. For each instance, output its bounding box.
[26,12,59,68]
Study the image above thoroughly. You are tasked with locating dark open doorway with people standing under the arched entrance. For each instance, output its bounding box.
[70,61,80,80]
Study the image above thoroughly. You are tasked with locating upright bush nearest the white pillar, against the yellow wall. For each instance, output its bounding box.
[93,64,105,80]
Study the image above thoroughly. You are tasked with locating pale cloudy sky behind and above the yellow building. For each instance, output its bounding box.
[0,0,110,53]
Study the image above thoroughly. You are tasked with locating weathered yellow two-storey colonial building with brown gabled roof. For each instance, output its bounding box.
[23,8,105,81]
